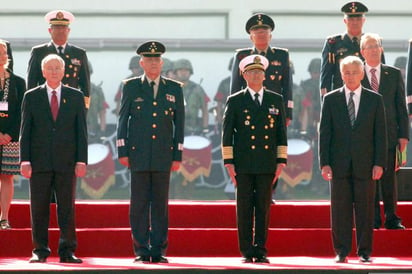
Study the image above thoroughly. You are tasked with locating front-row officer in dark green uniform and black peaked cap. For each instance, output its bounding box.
[117,41,185,263]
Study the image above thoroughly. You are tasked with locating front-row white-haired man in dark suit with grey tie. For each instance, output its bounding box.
[319,56,387,263]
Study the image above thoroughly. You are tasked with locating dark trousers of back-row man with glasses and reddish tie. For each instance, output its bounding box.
[375,149,400,224]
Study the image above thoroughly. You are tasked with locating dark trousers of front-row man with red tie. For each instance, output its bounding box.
[30,171,77,257]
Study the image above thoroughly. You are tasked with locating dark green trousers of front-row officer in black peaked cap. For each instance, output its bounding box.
[129,172,170,256]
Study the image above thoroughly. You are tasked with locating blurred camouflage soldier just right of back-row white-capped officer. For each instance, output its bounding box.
[87,62,109,142]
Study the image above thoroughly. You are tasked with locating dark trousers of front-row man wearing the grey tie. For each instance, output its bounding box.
[331,174,376,256]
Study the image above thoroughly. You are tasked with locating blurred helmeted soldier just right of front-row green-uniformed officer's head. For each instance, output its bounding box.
[173,59,209,136]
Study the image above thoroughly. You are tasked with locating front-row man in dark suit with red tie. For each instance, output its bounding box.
[20,54,87,263]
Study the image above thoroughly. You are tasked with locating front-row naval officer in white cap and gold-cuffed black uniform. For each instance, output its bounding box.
[222,54,287,263]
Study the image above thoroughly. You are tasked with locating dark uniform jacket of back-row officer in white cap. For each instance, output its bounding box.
[27,42,90,97]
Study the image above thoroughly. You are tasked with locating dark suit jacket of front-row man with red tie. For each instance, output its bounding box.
[20,85,87,172]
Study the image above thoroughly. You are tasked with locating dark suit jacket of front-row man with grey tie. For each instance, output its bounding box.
[319,87,387,179]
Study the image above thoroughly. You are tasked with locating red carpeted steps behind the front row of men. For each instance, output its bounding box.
[0,201,412,257]
